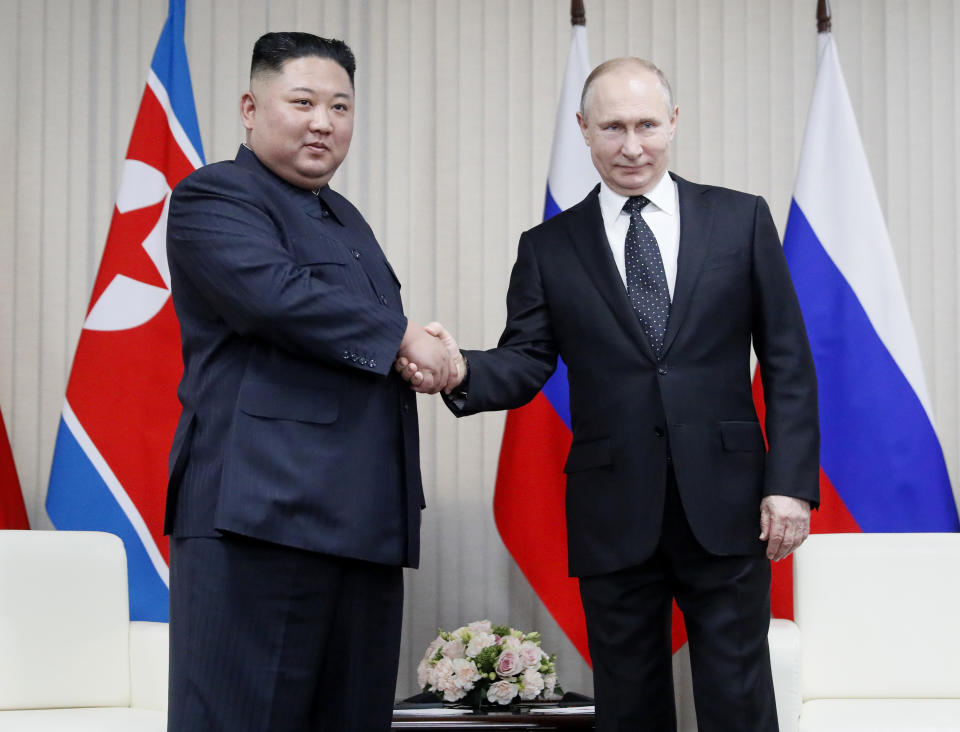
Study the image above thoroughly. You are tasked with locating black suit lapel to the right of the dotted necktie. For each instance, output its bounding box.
[663,178,713,355]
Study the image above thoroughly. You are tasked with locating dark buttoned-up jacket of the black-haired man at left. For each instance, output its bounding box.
[165,147,423,566]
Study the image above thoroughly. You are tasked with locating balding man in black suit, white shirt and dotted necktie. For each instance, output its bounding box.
[397,59,819,732]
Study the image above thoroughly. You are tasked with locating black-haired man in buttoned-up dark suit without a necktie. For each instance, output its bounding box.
[166,33,449,732]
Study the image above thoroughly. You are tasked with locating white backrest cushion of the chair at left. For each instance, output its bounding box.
[0,531,130,709]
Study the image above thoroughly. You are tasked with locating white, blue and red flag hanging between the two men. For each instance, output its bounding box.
[493,25,599,663]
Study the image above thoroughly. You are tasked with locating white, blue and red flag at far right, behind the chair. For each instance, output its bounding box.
[774,32,960,615]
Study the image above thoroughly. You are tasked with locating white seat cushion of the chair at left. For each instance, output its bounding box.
[0,708,167,732]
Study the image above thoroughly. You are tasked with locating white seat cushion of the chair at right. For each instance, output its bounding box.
[800,699,960,732]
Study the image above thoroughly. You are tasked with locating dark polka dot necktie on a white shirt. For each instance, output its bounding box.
[623,196,670,359]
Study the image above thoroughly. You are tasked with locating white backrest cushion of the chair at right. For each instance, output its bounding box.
[794,534,960,696]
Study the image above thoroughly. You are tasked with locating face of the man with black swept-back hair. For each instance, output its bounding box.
[240,56,353,190]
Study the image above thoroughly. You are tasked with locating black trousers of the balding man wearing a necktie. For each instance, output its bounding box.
[580,470,778,732]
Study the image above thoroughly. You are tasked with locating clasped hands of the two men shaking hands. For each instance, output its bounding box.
[393,321,467,394]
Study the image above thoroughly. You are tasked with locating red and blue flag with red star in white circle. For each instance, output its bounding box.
[46,0,203,621]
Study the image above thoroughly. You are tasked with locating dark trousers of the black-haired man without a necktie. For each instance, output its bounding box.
[167,535,403,732]
